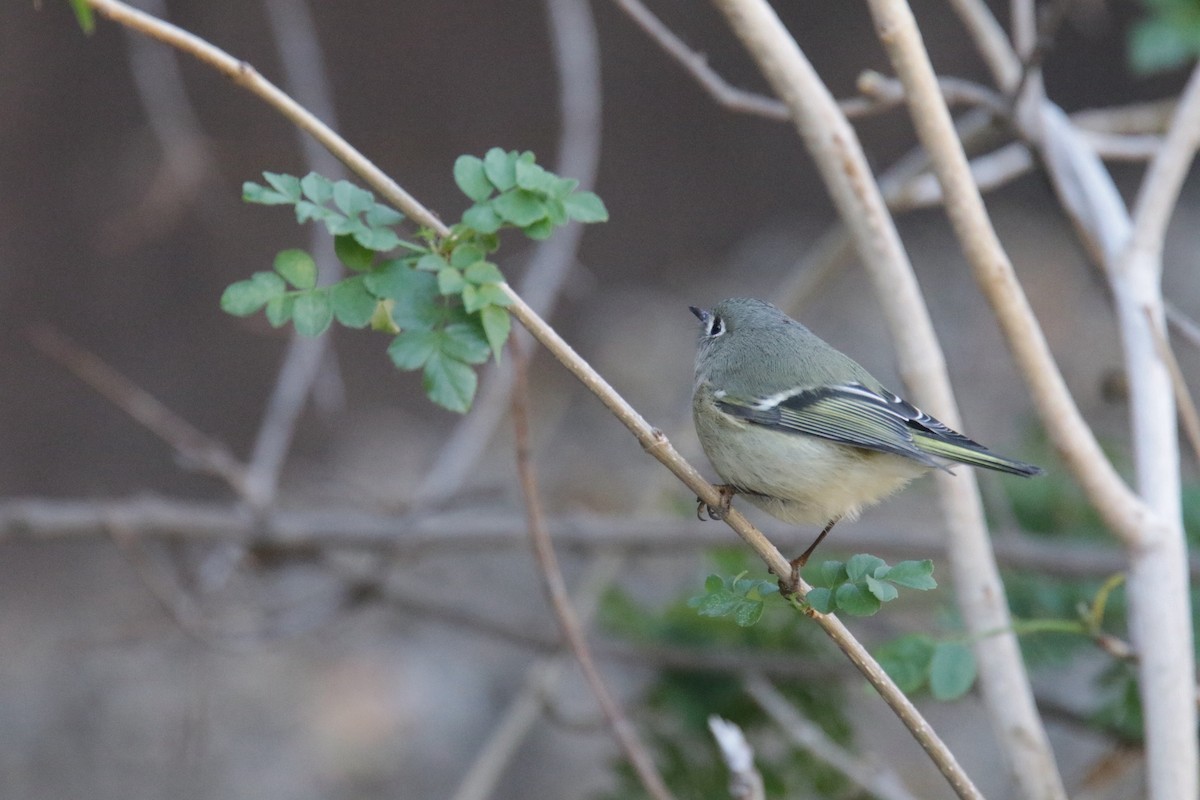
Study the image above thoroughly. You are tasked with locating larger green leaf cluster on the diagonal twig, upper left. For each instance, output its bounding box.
[221,153,607,413]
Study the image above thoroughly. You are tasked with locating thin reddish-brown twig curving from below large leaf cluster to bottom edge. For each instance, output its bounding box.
[512,344,672,800]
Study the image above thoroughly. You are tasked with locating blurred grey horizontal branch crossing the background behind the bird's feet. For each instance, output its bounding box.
[7,497,1200,578]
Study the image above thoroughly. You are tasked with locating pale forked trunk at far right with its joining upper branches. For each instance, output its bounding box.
[871,0,1200,799]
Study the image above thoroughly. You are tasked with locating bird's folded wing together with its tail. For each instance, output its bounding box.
[716,383,1042,475]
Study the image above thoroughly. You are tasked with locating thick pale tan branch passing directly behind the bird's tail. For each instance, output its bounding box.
[716,0,1066,798]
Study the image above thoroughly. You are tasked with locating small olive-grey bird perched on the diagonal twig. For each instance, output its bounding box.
[690,297,1043,575]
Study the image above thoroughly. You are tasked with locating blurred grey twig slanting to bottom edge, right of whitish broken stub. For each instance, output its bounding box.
[743,673,914,800]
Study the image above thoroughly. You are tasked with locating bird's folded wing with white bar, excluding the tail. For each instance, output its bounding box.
[715,383,958,467]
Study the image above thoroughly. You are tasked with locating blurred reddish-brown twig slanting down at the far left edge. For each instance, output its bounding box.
[29,325,245,494]
